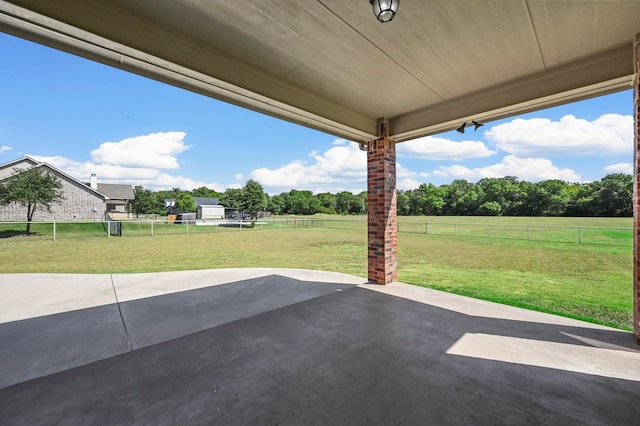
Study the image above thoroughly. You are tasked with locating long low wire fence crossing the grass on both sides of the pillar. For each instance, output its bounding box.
[0,217,633,246]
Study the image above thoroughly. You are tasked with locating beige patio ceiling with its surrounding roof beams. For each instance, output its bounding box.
[0,0,640,142]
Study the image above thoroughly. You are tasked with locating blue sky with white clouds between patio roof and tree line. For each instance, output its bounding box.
[0,33,633,194]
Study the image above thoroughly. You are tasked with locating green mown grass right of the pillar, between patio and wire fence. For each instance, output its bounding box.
[398,234,633,330]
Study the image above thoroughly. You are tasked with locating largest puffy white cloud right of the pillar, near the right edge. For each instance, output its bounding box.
[485,114,633,157]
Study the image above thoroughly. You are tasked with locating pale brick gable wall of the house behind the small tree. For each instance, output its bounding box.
[0,171,106,222]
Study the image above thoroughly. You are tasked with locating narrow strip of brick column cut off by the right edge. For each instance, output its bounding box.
[633,34,640,344]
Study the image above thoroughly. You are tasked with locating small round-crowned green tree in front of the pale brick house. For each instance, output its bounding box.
[0,167,64,235]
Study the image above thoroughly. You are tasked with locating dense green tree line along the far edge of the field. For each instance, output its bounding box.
[131,173,633,217]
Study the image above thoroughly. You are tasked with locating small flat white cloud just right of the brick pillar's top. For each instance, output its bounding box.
[396,136,496,161]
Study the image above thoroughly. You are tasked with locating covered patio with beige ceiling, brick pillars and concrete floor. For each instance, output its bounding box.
[0,0,640,424]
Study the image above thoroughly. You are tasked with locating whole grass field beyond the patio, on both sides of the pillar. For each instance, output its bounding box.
[0,217,633,329]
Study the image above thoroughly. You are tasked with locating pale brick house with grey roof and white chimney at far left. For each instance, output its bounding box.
[0,157,134,221]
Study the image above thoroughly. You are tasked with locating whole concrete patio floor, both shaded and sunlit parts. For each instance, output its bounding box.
[0,269,640,425]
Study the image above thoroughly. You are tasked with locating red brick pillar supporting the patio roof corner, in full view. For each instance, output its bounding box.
[367,135,398,284]
